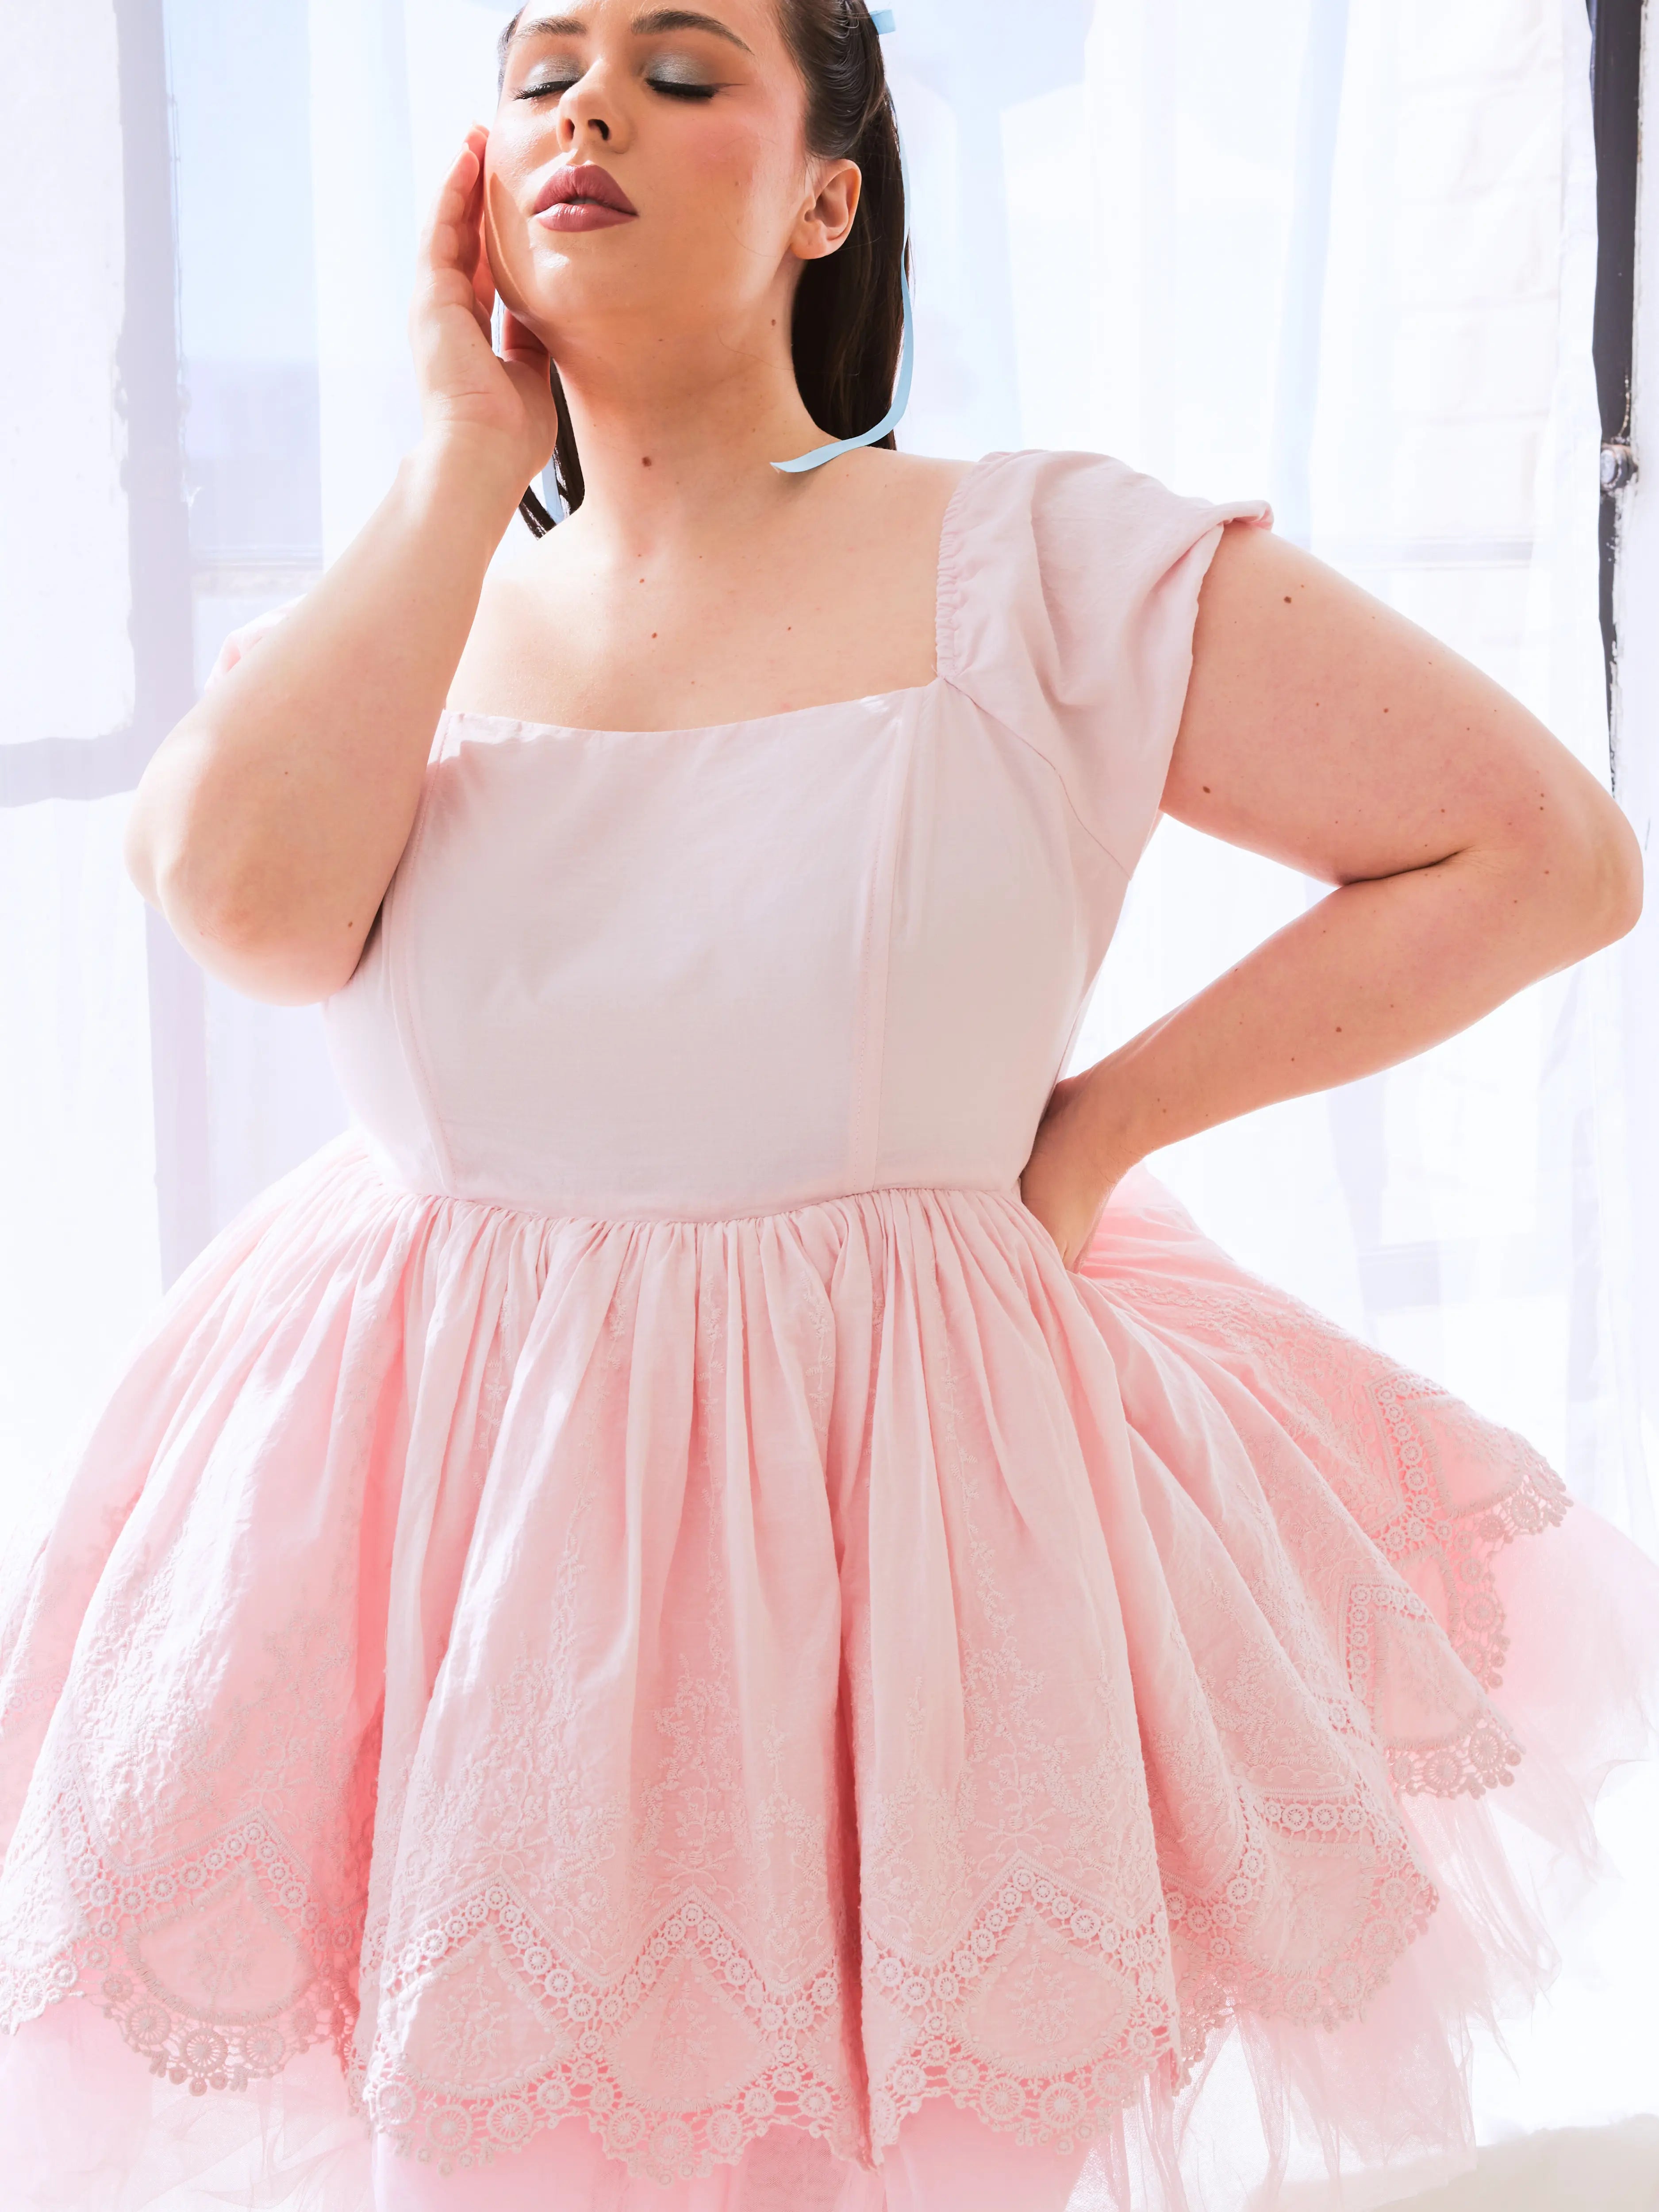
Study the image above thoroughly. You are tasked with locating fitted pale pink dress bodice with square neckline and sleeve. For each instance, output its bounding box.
[327,442,1261,1219]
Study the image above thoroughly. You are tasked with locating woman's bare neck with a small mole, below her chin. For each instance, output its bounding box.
[546,310,825,560]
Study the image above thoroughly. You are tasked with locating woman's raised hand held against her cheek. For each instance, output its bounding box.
[409,124,560,500]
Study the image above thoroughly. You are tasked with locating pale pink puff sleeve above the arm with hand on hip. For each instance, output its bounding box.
[938,453,1272,876]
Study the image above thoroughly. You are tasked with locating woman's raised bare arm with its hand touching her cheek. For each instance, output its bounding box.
[126,131,557,1004]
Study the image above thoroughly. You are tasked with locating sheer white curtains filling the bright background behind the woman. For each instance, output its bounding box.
[0,0,1659,2185]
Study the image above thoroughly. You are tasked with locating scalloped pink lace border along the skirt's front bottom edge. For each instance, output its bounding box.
[7,1798,1460,2183]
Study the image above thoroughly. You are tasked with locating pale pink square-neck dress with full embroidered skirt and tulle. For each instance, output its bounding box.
[0,453,1659,2212]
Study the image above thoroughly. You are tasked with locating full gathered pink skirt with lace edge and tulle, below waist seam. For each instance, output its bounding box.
[0,1139,1659,2212]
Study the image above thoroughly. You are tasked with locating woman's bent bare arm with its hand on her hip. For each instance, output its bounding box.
[1022,526,1641,1263]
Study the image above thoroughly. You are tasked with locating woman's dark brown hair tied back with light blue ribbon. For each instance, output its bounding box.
[498,0,907,538]
